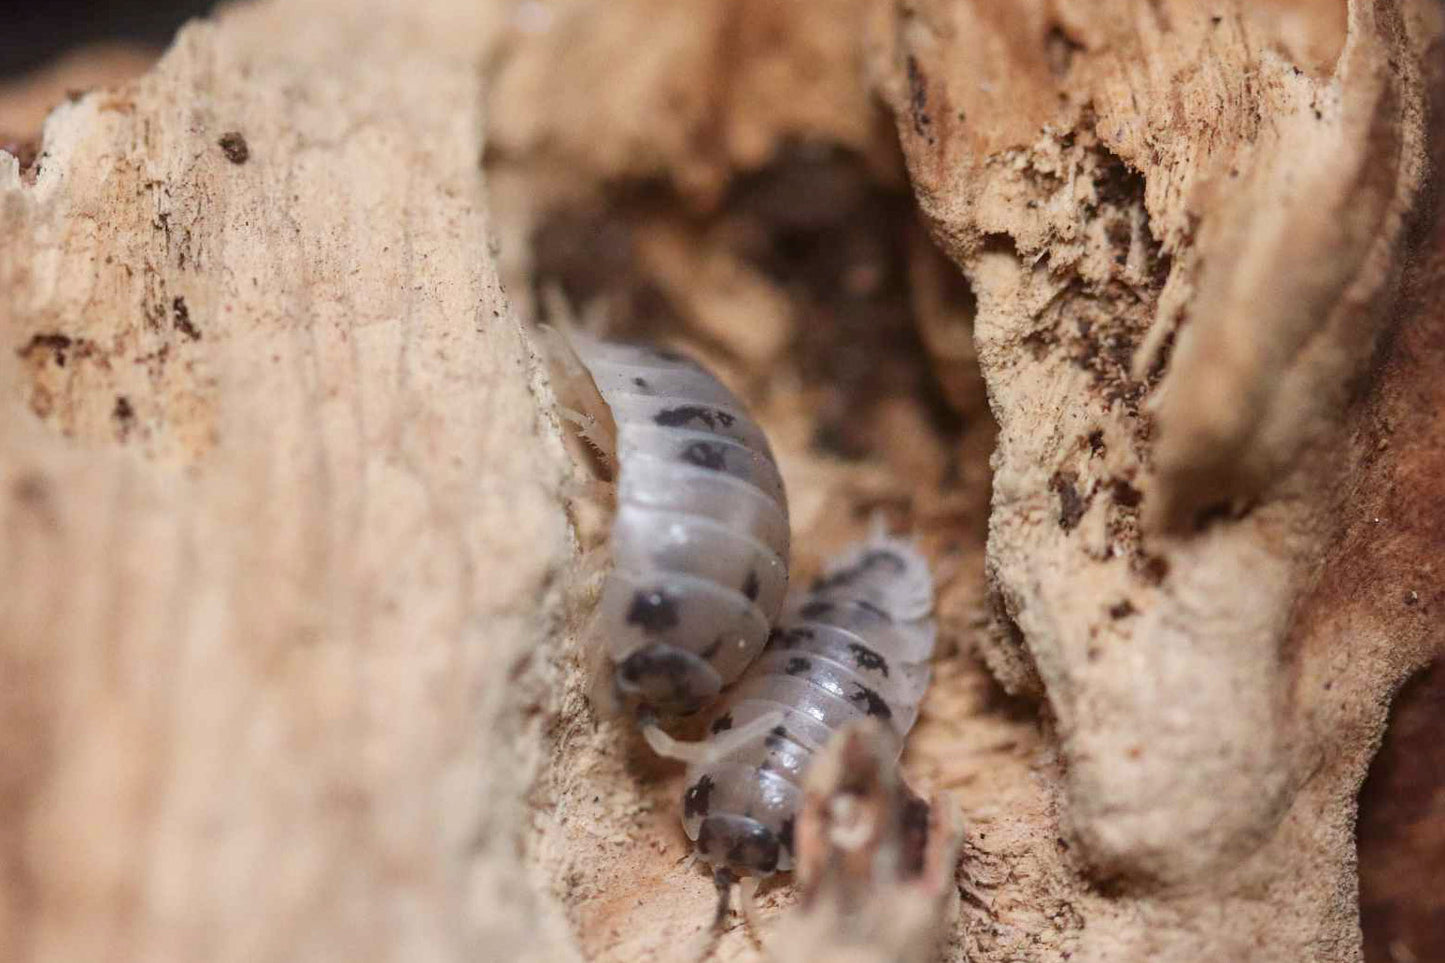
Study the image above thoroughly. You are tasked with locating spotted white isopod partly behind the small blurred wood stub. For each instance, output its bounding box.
[682,532,936,920]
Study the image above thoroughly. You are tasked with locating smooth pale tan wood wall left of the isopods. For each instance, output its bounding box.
[0,0,571,960]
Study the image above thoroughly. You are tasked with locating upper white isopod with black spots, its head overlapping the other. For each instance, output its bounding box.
[552,322,789,720]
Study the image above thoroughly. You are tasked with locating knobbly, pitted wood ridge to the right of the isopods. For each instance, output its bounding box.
[877,0,1445,959]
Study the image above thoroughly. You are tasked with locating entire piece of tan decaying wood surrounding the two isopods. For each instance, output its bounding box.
[0,0,1445,963]
